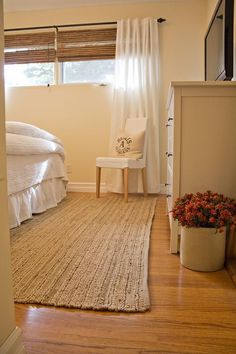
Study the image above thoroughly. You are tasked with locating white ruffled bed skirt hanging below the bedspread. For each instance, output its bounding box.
[8,178,67,229]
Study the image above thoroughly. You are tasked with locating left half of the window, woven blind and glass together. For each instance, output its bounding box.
[4,32,56,86]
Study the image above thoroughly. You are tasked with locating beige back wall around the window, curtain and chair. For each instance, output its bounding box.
[5,0,206,183]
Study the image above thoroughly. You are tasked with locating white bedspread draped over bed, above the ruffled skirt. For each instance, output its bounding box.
[6,121,66,194]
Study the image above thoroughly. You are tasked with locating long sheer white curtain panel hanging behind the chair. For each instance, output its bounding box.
[107,18,160,193]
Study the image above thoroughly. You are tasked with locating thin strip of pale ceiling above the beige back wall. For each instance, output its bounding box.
[4,0,168,12]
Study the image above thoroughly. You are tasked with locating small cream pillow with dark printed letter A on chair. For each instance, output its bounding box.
[114,131,145,159]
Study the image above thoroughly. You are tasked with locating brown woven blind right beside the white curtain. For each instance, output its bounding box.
[57,28,116,62]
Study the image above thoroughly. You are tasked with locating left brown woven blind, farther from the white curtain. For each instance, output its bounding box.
[4,32,56,64]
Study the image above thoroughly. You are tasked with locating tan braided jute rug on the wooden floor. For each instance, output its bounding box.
[11,193,156,312]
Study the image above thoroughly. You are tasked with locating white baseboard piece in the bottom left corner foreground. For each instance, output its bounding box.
[0,327,26,354]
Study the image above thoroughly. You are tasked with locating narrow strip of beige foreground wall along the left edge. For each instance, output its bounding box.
[0,1,15,350]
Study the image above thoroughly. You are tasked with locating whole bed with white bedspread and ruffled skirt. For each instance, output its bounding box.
[6,121,67,228]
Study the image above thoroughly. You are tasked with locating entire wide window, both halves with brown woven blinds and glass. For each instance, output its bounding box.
[4,27,116,86]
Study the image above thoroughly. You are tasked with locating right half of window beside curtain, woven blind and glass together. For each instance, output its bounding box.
[57,28,116,83]
